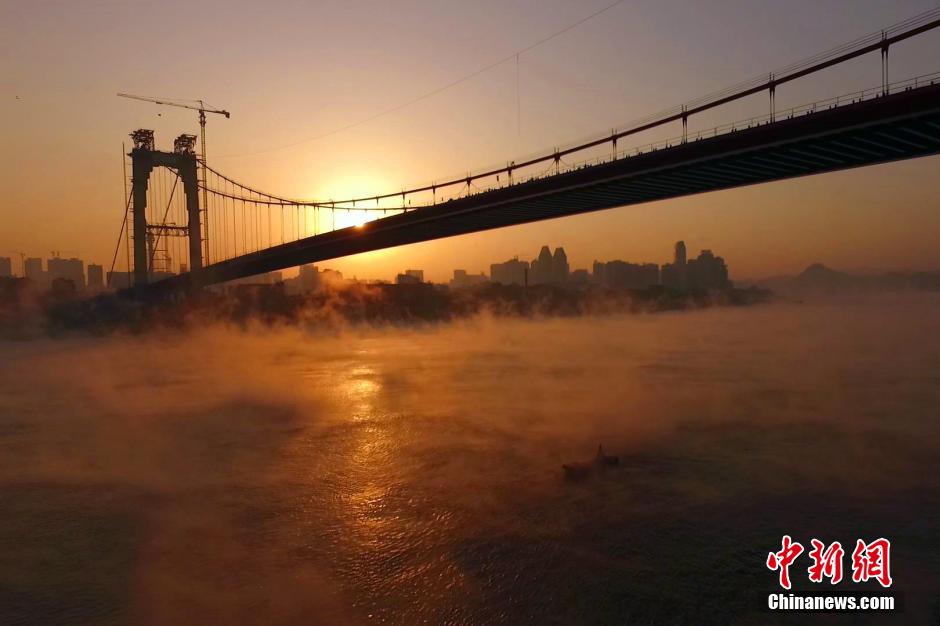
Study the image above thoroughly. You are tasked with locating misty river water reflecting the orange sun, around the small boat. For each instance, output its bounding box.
[0,295,940,624]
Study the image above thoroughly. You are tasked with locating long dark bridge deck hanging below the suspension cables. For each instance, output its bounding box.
[150,80,940,291]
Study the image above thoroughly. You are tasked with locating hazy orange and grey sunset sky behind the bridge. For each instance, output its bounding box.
[0,0,940,280]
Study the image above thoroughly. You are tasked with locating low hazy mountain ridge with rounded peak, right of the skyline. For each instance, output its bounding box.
[754,263,940,294]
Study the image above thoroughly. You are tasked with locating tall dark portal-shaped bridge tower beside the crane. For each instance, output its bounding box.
[129,129,202,286]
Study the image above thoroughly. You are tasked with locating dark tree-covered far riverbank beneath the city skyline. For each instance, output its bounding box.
[3,283,772,337]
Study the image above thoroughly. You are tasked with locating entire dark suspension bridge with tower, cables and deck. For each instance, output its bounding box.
[119,9,940,293]
